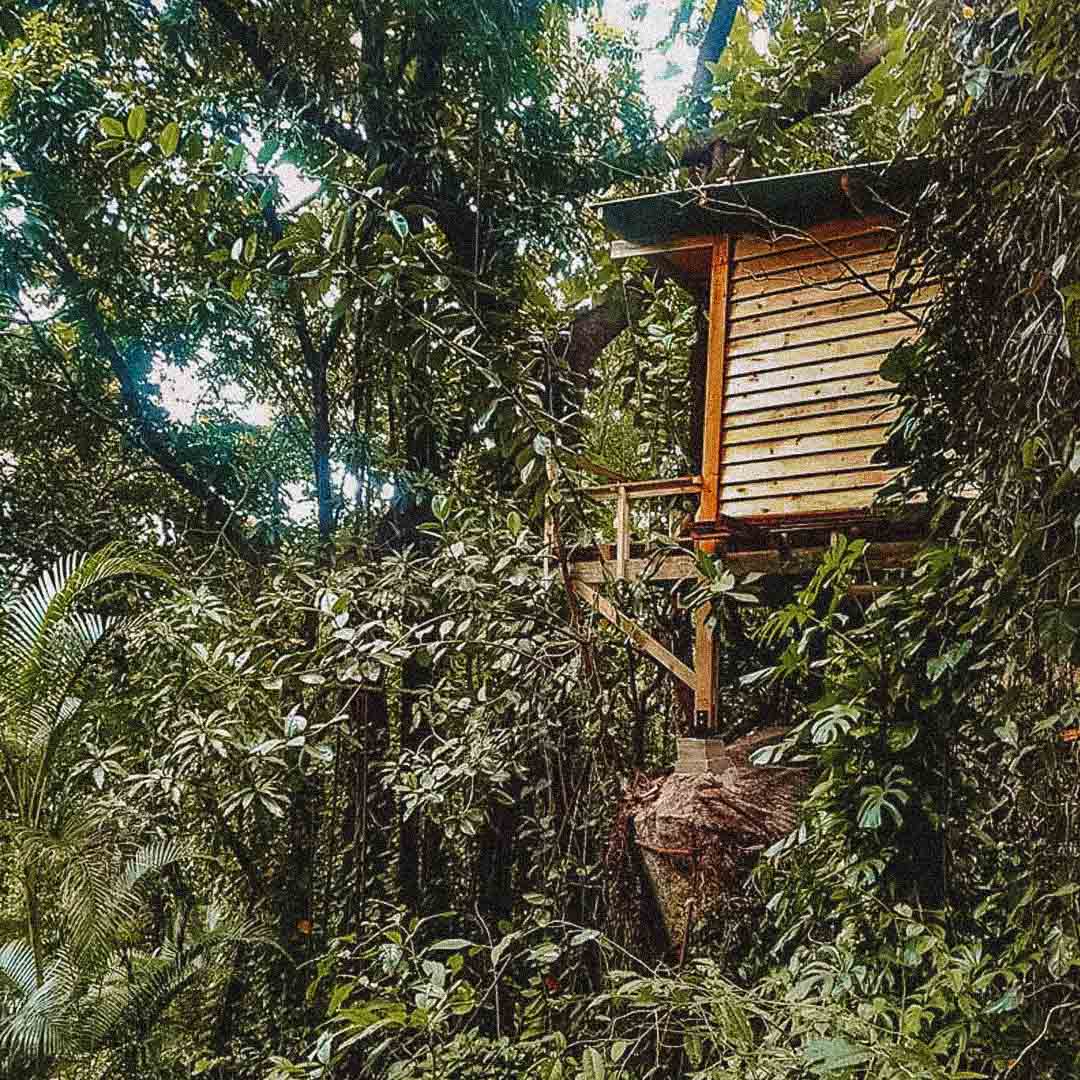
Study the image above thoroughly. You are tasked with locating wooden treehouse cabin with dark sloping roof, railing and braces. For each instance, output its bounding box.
[571,162,932,728]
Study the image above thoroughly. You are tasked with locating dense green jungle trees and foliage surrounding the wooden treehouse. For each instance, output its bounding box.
[0,0,1080,1080]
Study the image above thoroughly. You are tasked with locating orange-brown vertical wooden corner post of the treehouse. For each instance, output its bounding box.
[693,235,733,732]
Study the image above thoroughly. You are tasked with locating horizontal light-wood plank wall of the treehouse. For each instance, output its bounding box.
[702,219,931,518]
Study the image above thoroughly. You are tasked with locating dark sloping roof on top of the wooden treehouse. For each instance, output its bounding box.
[596,160,929,244]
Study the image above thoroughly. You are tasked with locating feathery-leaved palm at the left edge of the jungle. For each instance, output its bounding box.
[0,544,227,1067]
